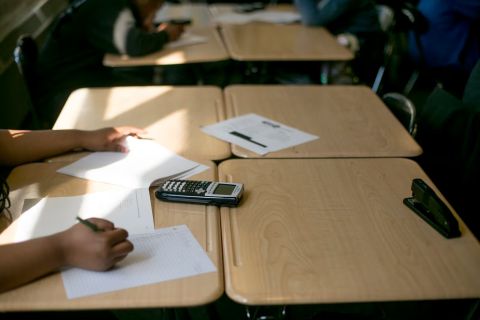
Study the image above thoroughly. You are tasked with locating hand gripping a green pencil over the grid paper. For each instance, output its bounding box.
[59,218,133,271]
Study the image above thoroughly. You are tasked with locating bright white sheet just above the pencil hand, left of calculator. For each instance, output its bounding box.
[12,188,154,242]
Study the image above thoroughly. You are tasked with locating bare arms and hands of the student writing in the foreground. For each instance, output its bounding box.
[0,127,141,292]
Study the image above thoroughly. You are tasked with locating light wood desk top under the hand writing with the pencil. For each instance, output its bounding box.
[0,162,223,311]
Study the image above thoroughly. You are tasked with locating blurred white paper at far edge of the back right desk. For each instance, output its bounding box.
[214,10,300,24]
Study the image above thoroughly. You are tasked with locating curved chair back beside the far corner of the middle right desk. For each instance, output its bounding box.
[382,92,417,137]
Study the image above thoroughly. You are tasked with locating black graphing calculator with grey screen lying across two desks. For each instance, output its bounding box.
[155,179,243,207]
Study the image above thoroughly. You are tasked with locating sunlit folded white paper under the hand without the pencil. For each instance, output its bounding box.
[58,137,208,188]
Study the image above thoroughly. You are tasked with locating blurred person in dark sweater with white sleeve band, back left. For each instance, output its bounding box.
[32,0,184,126]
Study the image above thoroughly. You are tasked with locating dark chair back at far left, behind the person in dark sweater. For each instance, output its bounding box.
[13,35,39,128]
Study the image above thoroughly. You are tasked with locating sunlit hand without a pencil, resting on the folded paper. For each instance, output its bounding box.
[81,127,144,152]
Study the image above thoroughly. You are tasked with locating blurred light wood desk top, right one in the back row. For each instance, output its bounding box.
[221,23,353,61]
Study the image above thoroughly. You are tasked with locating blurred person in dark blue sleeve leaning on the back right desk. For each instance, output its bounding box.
[294,0,384,84]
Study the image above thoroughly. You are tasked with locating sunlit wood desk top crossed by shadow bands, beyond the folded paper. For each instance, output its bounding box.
[54,86,231,160]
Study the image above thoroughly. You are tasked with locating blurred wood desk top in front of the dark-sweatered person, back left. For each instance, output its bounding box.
[103,25,229,67]
